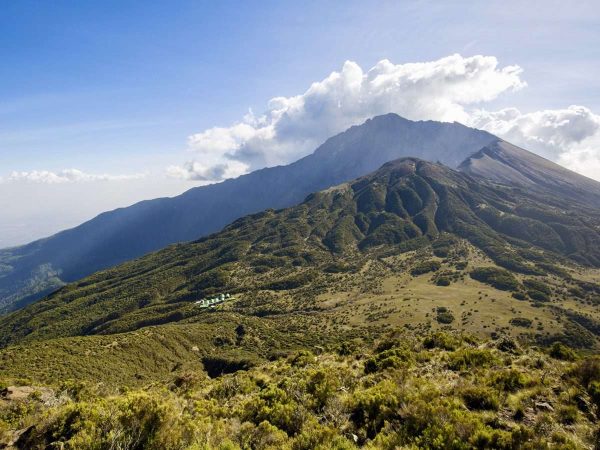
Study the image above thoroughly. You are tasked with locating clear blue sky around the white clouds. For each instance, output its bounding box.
[0,0,600,247]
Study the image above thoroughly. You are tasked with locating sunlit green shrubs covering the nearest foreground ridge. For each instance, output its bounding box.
[0,333,600,450]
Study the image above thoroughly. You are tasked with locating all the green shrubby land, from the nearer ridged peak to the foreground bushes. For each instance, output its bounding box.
[0,158,600,449]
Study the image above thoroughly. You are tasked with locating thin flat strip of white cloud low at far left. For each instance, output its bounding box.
[0,169,145,184]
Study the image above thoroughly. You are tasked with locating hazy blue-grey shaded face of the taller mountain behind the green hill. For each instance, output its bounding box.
[0,114,496,311]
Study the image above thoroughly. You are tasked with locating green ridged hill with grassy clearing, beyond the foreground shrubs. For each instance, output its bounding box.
[0,159,600,384]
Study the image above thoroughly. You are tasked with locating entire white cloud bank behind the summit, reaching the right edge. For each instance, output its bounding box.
[167,55,600,182]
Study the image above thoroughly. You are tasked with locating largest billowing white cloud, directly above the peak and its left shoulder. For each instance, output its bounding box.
[168,55,525,181]
